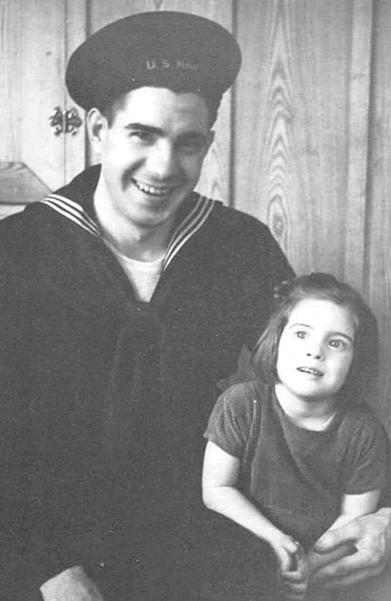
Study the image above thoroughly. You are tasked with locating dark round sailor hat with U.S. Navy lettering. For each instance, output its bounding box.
[66,11,241,110]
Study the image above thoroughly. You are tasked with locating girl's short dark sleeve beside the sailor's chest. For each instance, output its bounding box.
[204,382,256,459]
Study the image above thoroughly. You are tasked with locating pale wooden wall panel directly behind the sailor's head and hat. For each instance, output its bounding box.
[90,0,233,202]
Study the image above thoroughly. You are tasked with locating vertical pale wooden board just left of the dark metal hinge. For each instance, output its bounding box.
[21,0,66,189]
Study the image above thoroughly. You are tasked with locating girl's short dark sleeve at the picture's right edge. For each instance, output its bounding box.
[345,411,389,494]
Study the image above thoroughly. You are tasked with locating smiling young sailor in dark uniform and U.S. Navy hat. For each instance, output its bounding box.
[0,12,390,601]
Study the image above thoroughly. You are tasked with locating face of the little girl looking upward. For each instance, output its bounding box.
[277,298,355,401]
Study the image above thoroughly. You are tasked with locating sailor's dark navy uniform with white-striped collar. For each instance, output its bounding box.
[0,167,291,601]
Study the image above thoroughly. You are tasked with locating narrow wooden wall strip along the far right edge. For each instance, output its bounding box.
[365,0,391,426]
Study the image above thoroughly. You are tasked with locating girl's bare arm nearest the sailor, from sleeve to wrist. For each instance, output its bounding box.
[202,441,299,571]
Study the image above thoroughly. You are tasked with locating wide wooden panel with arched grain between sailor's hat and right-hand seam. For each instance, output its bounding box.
[235,0,352,276]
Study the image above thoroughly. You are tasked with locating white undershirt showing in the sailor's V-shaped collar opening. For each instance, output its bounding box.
[105,240,164,303]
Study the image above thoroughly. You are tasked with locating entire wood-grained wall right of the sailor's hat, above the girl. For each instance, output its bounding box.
[234,0,391,426]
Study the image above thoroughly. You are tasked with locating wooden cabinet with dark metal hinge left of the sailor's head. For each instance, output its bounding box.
[0,0,86,192]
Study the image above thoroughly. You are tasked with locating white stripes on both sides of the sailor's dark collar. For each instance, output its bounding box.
[40,194,220,269]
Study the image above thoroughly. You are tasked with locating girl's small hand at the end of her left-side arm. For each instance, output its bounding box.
[280,539,309,601]
